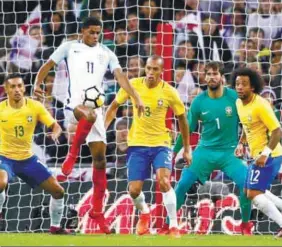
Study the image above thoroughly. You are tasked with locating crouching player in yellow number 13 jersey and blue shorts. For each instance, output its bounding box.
[0,74,70,234]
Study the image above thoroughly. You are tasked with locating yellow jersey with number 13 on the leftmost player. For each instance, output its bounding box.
[0,98,55,160]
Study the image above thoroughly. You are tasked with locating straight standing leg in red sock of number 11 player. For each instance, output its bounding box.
[88,141,112,234]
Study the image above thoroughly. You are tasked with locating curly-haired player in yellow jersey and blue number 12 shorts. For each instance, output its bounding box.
[232,68,282,237]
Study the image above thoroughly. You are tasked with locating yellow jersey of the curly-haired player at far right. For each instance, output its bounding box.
[236,94,282,158]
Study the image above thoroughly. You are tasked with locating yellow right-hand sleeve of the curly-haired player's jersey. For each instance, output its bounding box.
[256,101,280,131]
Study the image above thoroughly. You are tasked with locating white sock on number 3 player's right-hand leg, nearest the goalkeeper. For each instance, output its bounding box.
[162,188,178,228]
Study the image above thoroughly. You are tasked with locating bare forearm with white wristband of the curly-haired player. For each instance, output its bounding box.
[256,128,281,167]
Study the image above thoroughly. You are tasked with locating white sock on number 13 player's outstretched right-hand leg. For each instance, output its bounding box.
[49,197,64,227]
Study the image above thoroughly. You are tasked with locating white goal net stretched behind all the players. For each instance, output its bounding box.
[0,0,282,234]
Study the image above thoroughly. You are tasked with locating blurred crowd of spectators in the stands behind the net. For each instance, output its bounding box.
[0,0,282,179]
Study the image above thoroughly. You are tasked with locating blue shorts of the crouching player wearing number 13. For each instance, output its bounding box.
[0,155,52,188]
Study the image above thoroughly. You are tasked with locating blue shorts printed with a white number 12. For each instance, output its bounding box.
[245,156,282,192]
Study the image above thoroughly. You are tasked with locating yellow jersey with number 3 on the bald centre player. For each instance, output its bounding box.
[116,77,185,147]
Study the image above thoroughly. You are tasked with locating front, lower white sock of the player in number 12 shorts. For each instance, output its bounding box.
[253,194,282,227]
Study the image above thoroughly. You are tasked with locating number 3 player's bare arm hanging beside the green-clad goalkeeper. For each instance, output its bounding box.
[177,113,192,165]
